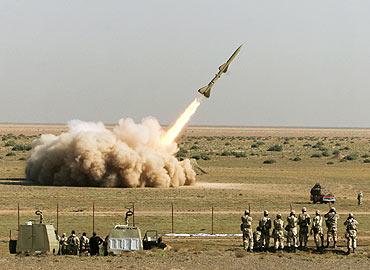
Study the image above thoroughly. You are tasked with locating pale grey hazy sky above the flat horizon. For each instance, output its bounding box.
[0,0,370,127]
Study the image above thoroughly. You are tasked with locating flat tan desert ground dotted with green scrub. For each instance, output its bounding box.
[0,124,370,269]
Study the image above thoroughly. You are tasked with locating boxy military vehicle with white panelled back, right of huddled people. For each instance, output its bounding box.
[107,209,143,255]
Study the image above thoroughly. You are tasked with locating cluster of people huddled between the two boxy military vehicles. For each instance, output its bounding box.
[59,230,105,256]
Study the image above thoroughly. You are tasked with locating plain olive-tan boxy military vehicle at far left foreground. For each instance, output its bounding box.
[9,210,59,255]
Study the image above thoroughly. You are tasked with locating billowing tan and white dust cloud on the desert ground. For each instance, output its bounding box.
[26,118,196,187]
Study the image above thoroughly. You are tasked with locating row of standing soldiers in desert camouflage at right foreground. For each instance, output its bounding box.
[240,207,358,253]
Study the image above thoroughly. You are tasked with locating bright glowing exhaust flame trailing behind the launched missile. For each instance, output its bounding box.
[161,97,202,145]
